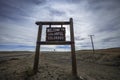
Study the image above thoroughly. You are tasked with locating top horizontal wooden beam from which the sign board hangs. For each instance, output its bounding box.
[36,21,70,25]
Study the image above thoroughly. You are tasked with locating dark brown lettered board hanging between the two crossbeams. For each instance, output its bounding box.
[46,27,65,41]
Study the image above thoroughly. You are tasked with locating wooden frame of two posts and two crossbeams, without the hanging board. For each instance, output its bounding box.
[33,18,77,77]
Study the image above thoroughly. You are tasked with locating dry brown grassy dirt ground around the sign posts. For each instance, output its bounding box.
[0,49,120,80]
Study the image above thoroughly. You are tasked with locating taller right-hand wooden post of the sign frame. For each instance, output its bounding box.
[70,18,77,77]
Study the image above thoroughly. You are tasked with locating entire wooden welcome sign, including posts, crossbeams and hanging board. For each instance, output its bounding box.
[33,18,78,78]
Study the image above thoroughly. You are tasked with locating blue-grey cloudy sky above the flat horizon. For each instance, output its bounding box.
[0,0,120,51]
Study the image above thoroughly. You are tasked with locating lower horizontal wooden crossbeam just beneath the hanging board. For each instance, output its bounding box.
[38,41,71,45]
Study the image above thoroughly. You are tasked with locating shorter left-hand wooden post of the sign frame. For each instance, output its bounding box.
[33,24,42,74]
